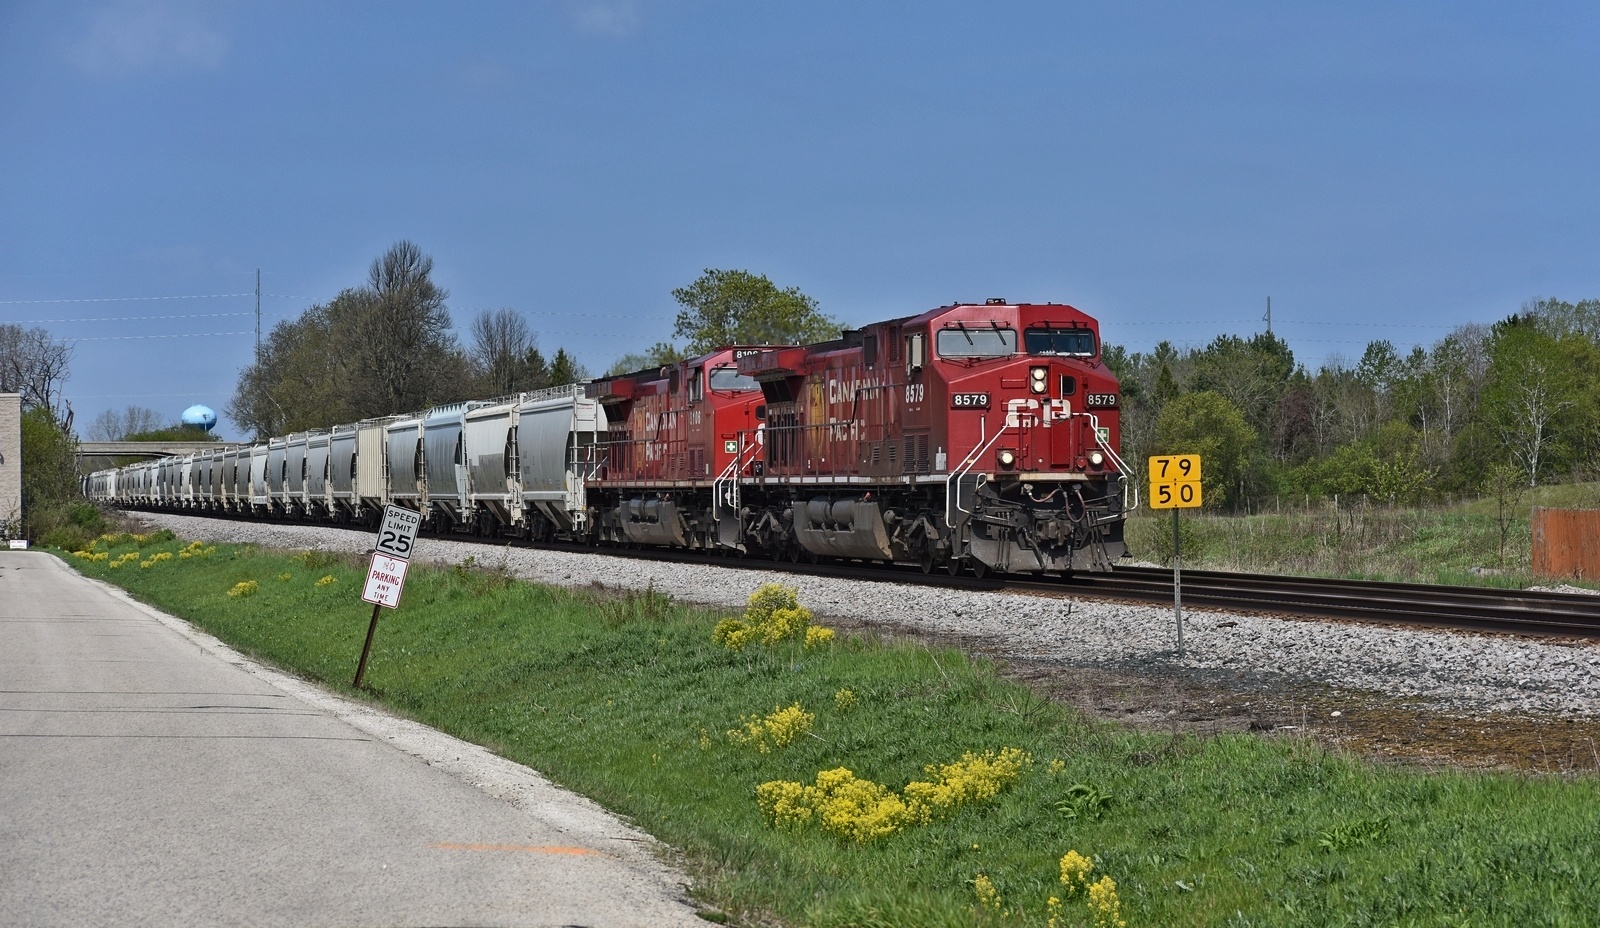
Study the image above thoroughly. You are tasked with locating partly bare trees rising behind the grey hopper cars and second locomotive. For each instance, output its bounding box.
[232,242,838,437]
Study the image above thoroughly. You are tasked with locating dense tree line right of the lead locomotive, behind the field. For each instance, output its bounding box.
[1104,299,1600,510]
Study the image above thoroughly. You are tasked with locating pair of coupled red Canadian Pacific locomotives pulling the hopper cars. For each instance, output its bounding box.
[586,299,1126,576]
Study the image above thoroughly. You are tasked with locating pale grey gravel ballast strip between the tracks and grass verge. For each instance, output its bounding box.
[131,512,1600,718]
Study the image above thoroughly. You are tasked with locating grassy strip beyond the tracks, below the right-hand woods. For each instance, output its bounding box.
[1128,483,1600,589]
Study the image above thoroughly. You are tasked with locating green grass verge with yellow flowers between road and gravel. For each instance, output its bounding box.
[69,536,1600,928]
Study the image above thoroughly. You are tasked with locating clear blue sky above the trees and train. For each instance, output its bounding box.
[0,0,1600,437]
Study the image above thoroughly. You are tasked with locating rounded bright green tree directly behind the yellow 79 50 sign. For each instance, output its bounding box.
[1152,390,1258,507]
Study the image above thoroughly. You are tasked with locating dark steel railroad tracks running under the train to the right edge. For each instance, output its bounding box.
[128,514,1600,640]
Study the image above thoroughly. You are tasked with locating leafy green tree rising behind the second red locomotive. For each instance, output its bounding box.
[672,269,840,355]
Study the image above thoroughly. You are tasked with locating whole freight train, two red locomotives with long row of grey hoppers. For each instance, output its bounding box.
[85,299,1136,576]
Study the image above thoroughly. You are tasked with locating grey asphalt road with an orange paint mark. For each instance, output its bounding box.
[0,552,706,926]
